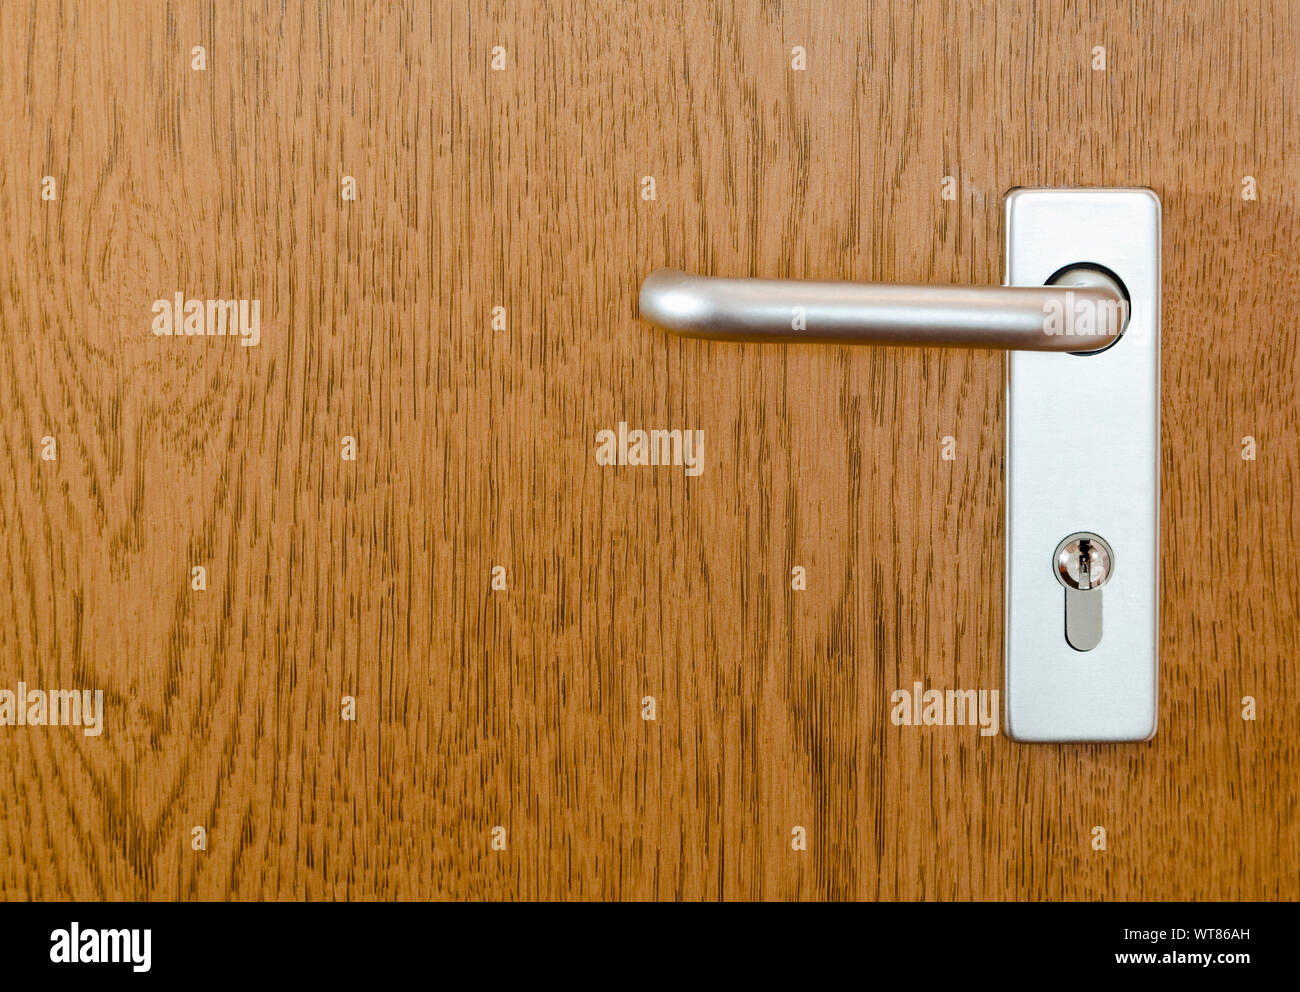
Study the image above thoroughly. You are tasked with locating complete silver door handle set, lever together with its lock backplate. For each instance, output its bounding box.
[640,189,1161,741]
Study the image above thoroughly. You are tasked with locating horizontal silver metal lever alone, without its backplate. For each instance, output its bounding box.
[641,268,1127,352]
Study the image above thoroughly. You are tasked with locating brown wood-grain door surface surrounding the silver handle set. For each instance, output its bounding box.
[0,0,1300,900]
